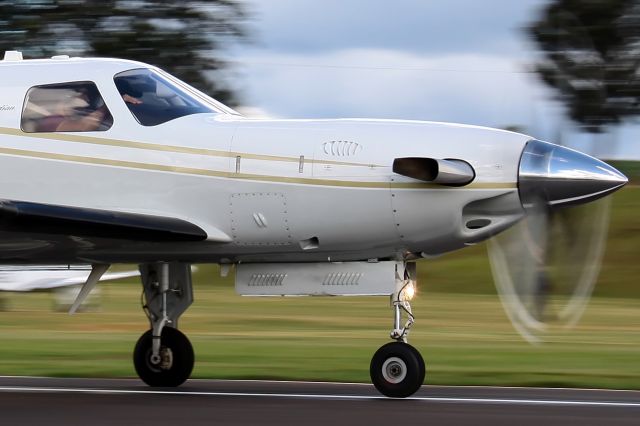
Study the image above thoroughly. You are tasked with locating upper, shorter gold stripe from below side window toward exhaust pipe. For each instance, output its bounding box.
[0,127,383,167]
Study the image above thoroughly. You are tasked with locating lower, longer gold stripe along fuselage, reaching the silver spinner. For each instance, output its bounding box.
[0,148,516,190]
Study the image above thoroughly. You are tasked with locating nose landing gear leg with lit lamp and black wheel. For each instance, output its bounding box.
[369,263,426,398]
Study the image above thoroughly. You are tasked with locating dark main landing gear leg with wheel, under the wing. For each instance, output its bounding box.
[133,263,194,387]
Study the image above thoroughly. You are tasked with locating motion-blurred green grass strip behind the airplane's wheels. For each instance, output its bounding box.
[0,188,640,389]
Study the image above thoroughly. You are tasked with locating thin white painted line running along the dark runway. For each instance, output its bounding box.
[0,386,640,408]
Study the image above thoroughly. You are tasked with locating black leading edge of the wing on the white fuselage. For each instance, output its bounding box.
[0,200,207,242]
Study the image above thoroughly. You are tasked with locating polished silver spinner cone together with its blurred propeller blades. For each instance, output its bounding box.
[489,141,627,343]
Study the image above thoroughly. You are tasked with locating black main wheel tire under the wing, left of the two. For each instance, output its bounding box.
[133,327,195,387]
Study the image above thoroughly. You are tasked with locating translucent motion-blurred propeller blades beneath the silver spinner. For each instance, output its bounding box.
[488,198,610,344]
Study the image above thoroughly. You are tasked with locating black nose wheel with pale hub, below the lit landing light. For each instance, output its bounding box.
[369,342,426,398]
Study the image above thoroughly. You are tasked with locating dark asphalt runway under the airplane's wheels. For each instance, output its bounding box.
[0,377,640,426]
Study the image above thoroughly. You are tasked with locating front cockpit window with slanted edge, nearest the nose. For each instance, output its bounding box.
[114,69,230,126]
